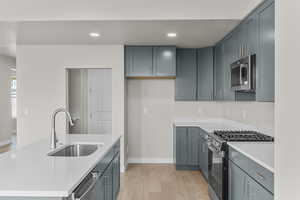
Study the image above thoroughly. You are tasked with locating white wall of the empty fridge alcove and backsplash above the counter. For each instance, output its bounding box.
[127,80,274,162]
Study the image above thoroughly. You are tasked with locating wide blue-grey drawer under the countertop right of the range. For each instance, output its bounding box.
[229,147,274,193]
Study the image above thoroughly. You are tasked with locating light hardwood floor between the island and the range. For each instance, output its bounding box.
[118,165,209,200]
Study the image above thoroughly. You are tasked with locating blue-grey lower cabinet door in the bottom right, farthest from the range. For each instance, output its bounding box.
[247,176,274,200]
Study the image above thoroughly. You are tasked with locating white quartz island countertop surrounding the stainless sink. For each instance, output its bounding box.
[0,134,120,197]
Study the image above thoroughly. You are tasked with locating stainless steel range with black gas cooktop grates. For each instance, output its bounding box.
[207,131,274,200]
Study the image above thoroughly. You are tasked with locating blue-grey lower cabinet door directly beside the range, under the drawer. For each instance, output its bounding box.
[228,161,247,200]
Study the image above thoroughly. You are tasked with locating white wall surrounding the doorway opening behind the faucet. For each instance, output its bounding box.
[17,45,124,170]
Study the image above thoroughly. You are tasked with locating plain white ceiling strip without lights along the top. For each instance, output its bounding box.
[0,0,262,21]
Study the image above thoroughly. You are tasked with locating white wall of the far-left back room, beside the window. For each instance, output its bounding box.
[0,56,16,144]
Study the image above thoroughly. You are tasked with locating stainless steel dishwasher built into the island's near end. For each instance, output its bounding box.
[70,172,100,200]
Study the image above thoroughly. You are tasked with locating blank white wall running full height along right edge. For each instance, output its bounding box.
[275,0,300,200]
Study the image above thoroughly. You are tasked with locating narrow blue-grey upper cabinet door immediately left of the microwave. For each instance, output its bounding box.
[223,35,235,101]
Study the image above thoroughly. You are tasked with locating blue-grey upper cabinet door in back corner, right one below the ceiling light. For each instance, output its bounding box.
[197,47,214,101]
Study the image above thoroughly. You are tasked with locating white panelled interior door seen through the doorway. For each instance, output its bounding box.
[87,69,112,134]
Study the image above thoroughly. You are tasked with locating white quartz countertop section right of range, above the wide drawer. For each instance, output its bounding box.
[228,142,274,173]
